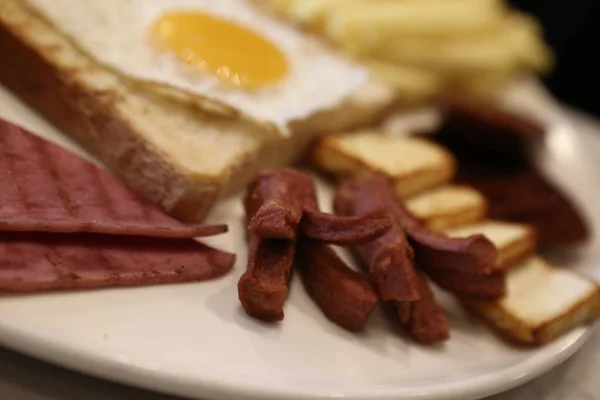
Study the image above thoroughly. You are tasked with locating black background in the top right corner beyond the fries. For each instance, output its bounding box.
[511,0,600,116]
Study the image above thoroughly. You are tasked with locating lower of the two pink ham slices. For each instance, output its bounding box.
[0,232,235,292]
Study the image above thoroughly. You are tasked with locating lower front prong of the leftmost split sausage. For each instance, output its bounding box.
[238,235,296,322]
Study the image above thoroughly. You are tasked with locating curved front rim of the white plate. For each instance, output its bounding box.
[0,318,597,400]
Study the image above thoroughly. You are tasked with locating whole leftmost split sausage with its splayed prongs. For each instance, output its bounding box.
[238,168,384,331]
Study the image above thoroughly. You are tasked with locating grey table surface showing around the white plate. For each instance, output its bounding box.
[0,106,600,400]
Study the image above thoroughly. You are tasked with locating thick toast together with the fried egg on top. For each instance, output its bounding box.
[0,0,394,221]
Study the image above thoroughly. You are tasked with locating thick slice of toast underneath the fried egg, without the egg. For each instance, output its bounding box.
[0,0,393,220]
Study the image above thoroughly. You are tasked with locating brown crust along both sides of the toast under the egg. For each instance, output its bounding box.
[0,0,393,221]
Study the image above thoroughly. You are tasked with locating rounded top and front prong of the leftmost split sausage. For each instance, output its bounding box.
[238,168,315,322]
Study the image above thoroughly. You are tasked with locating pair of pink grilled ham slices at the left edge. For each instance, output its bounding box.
[0,120,235,292]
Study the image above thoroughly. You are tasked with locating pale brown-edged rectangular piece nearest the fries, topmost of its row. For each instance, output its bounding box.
[311,131,456,197]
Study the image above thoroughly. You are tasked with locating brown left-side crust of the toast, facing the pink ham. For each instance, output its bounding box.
[0,3,218,219]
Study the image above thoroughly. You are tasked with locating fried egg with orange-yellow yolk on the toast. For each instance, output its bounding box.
[27,0,368,131]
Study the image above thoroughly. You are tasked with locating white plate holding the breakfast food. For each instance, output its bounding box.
[0,79,600,400]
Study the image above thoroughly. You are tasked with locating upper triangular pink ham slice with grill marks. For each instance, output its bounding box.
[0,120,227,238]
